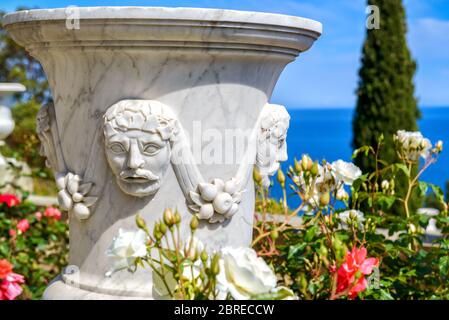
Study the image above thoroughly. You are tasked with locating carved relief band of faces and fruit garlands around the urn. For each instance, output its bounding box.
[37,100,290,223]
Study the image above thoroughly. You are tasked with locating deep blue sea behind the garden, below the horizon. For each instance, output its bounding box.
[271,107,449,202]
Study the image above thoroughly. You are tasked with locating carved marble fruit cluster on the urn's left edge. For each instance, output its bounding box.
[56,172,98,220]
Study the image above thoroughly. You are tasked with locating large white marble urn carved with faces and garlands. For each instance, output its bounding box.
[3,7,322,299]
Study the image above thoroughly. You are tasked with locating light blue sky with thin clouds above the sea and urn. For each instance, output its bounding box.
[0,0,449,108]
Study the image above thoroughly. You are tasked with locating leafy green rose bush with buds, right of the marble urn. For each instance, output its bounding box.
[253,134,449,300]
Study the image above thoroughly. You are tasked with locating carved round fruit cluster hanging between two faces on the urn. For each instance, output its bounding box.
[189,178,242,223]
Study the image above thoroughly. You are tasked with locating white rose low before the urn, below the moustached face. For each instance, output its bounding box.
[106,229,147,277]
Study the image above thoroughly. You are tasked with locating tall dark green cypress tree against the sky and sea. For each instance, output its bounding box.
[353,0,420,214]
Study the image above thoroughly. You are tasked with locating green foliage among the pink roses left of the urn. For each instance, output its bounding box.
[0,196,68,299]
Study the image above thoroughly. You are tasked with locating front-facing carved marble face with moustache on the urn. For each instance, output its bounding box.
[105,100,177,197]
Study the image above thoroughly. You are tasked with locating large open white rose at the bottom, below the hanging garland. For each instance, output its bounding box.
[217,247,276,300]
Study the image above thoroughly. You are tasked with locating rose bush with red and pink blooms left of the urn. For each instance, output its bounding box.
[0,194,68,299]
